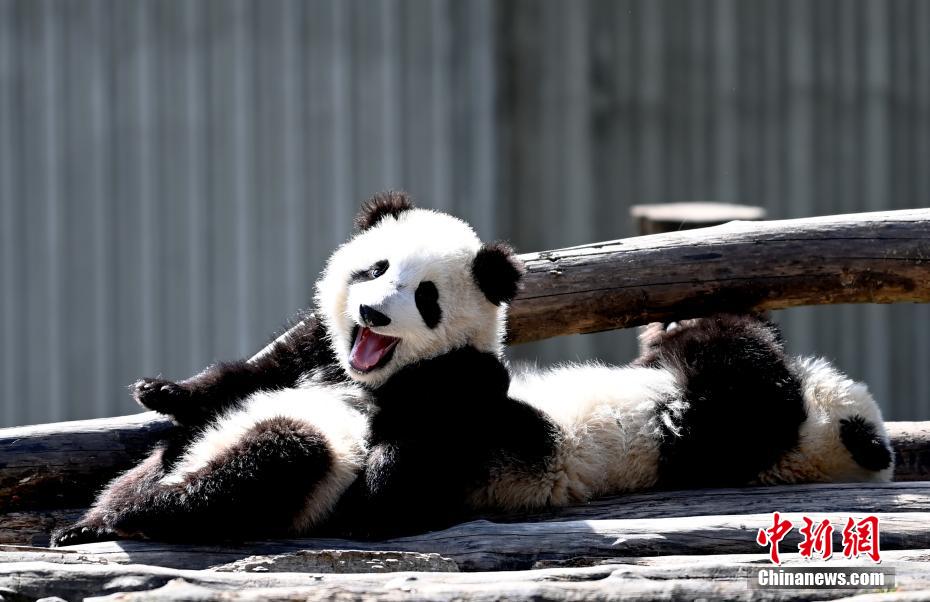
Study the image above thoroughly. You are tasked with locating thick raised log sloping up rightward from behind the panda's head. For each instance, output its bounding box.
[508,209,930,343]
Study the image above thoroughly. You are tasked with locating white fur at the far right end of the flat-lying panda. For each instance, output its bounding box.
[759,358,894,484]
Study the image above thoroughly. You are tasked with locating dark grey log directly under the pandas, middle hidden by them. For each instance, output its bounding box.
[7,482,930,546]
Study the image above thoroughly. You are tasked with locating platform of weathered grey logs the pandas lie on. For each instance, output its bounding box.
[0,482,930,600]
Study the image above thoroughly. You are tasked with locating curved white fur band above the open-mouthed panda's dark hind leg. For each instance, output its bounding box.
[162,383,368,531]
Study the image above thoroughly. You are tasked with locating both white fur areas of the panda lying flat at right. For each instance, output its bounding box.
[470,359,894,509]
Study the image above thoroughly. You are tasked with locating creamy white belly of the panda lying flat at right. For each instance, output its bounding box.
[472,364,678,509]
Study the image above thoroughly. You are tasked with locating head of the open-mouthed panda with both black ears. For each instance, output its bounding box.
[316,192,523,387]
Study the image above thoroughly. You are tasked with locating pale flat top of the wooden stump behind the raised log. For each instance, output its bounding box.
[630,202,765,236]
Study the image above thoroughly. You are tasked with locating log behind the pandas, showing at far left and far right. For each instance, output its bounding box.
[0,412,930,512]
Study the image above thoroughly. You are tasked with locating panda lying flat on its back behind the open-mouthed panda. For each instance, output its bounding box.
[472,315,893,508]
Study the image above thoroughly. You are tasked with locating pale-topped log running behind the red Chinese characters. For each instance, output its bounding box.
[16,508,930,571]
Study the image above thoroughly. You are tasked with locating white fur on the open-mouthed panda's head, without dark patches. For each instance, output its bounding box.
[316,209,506,385]
